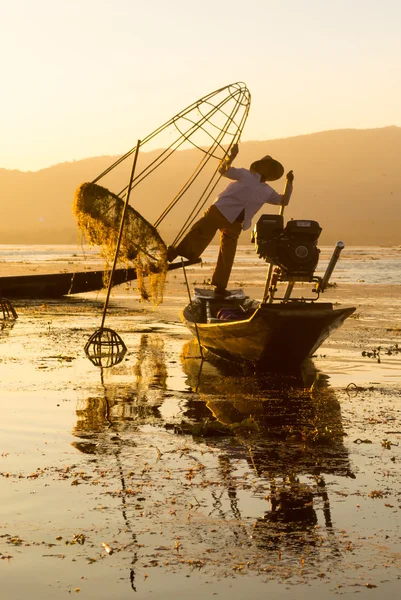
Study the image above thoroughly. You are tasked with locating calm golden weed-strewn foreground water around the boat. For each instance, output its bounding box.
[0,251,401,600]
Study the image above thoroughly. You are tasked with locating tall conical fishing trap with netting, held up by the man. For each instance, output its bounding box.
[74,82,251,364]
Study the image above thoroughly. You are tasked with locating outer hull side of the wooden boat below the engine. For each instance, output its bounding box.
[181,303,355,370]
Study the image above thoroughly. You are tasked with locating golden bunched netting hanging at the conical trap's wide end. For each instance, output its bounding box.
[73,183,167,304]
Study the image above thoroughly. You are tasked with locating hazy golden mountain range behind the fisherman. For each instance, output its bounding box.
[0,126,401,245]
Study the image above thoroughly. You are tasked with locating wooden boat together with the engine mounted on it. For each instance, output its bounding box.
[181,207,355,370]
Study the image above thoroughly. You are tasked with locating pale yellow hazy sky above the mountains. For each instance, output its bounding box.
[0,0,401,170]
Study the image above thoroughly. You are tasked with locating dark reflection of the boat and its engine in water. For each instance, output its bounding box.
[182,340,355,556]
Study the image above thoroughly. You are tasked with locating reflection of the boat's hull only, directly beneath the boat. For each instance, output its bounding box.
[182,341,345,448]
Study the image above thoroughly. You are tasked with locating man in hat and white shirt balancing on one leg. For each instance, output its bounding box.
[167,144,294,296]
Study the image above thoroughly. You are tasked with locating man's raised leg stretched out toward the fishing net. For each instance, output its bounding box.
[167,205,223,262]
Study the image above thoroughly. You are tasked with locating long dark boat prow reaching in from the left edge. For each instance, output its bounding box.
[0,261,199,298]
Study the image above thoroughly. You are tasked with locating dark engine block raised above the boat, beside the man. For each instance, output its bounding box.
[251,215,322,279]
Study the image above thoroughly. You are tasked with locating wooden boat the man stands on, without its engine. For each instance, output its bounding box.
[181,288,355,370]
